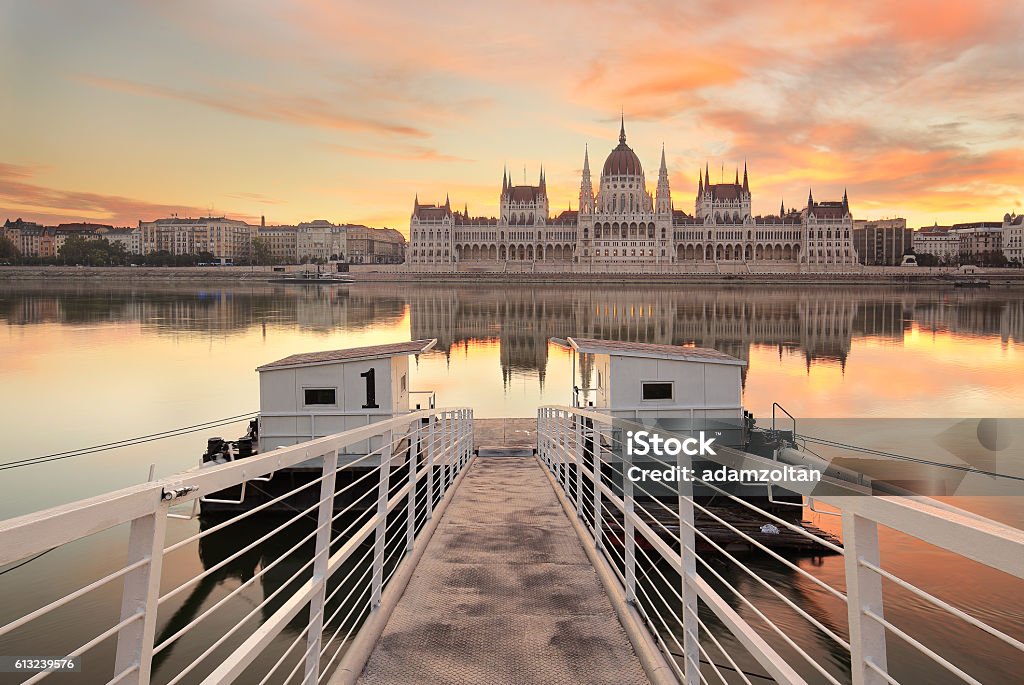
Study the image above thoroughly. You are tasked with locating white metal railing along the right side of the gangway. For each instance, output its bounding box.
[538,406,1024,685]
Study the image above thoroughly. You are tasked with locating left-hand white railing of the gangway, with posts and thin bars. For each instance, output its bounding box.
[0,409,473,685]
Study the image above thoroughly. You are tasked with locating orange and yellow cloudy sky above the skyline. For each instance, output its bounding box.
[0,0,1024,232]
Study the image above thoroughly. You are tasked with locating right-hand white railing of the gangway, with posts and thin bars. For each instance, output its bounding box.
[537,406,1024,685]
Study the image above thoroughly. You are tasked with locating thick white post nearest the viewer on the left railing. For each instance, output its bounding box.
[114,499,169,685]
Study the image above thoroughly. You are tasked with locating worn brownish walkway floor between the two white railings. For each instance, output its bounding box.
[359,457,647,685]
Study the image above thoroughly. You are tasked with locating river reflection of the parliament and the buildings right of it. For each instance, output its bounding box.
[407,288,1024,380]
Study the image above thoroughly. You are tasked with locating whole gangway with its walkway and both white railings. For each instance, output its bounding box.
[0,406,1024,685]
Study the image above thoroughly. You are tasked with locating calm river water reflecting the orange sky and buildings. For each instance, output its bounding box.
[0,282,1024,683]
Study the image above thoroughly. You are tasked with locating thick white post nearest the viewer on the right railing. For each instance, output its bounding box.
[843,511,889,685]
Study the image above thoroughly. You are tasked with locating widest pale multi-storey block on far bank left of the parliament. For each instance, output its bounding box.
[138,216,256,260]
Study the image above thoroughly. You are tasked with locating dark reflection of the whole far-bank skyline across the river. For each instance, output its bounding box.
[6,285,1024,381]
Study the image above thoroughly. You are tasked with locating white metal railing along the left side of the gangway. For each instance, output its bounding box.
[0,409,473,683]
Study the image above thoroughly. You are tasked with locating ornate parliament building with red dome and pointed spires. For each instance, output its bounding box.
[409,122,857,270]
